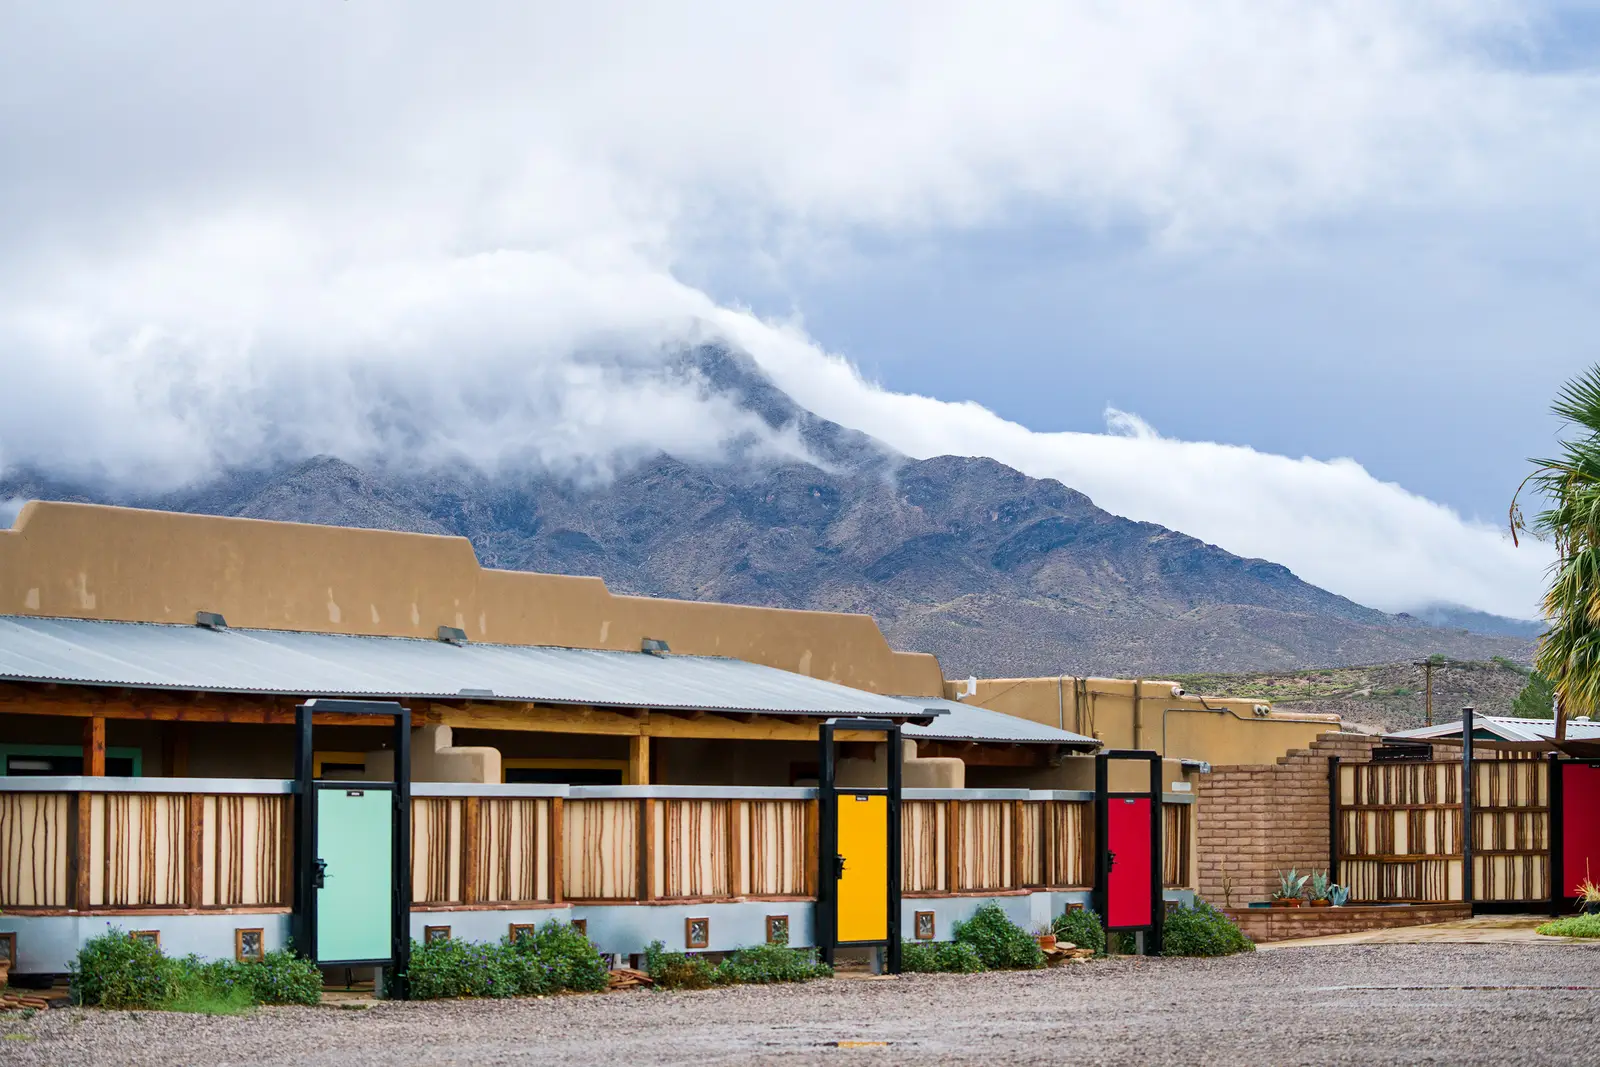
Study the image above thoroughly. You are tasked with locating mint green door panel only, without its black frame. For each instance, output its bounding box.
[317,787,394,963]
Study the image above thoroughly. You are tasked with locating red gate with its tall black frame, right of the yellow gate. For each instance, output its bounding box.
[1093,750,1165,955]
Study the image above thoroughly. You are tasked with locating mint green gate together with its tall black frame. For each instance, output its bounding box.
[290,701,411,1000]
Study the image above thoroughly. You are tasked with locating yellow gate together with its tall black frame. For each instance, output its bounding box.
[816,718,901,974]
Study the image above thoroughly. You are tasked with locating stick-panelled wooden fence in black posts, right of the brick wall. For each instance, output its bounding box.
[1334,760,1550,904]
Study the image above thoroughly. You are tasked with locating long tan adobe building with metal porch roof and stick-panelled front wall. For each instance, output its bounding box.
[0,502,1336,973]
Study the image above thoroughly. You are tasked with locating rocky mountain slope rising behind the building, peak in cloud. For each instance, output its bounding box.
[0,349,1530,677]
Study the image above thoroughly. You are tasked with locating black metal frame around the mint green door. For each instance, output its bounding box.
[290,699,411,1000]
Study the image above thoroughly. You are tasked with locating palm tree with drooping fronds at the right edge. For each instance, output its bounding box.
[1510,366,1600,741]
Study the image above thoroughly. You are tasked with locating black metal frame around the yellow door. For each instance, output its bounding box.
[813,718,904,974]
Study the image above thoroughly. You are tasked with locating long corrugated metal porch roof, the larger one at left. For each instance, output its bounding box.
[0,616,942,718]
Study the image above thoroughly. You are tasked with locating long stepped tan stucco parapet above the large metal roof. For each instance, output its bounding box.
[0,501,942,696]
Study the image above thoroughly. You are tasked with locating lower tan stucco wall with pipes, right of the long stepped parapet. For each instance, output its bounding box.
[946,677,1339,765]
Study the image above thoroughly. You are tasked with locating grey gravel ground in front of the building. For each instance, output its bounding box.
[0,944,1600,1067]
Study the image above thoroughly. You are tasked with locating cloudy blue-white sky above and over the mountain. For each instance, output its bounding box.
[0,0,1600,617]
